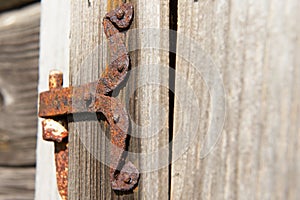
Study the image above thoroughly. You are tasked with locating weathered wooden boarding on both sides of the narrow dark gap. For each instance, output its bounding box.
[39,0,300,199]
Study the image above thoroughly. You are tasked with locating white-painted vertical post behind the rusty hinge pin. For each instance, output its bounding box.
[35,0,70,200]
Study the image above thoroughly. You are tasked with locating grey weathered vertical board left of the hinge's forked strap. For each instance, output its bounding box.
[69,0,112,200]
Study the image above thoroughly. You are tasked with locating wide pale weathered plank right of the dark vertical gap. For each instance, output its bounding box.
[171,0,300,199]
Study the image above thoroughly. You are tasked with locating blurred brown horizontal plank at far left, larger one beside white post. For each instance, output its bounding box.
[0,4,40,166]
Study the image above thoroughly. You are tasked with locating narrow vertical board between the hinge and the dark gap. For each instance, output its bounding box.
[129,0,169,199]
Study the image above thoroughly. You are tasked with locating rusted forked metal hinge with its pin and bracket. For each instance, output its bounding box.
[39,3,139,199]
